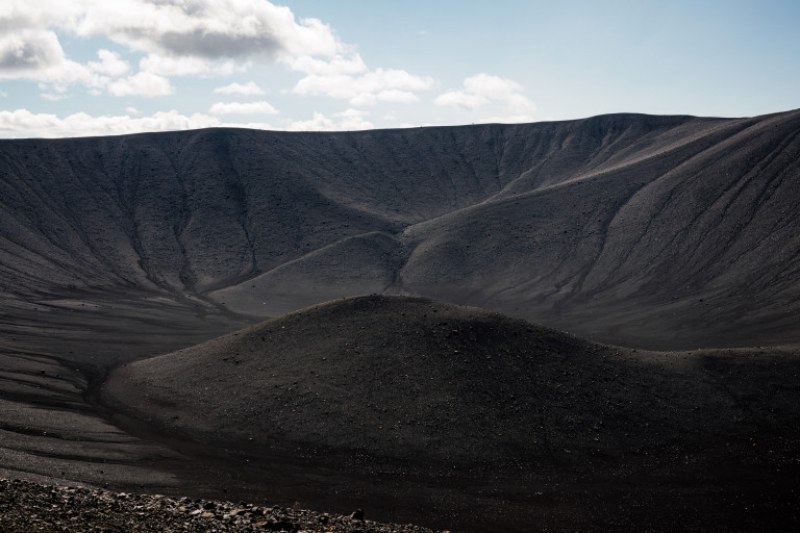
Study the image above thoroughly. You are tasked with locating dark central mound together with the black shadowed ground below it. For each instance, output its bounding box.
[103,296,800,531]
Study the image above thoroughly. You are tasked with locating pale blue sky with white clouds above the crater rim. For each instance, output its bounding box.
[0,0,800,138]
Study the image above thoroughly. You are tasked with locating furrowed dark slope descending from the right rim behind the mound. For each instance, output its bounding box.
[399,113,800,348]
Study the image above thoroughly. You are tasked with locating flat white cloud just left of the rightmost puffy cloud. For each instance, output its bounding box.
[292,68,434,106]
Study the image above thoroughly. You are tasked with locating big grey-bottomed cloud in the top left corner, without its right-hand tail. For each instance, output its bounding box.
[0,0,345,94]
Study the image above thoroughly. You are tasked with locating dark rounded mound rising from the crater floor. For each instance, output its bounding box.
[106,296,798,474]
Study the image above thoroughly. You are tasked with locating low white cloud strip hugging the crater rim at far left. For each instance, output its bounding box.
[0,109,222,137]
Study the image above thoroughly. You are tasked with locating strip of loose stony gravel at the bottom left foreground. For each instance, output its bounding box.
[0,479,440,533]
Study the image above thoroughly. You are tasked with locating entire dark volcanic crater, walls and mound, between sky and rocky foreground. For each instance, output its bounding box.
[0,110,800,532]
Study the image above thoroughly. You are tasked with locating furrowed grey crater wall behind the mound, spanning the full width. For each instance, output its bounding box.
[0,111,800,348]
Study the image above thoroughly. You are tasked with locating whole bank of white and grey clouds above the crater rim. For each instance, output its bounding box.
[0,0,536,137]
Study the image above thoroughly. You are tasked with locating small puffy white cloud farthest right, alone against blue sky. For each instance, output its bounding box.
[434,73,536,122]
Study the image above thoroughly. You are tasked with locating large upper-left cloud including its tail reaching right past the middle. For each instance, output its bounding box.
[0,0,433,106]
